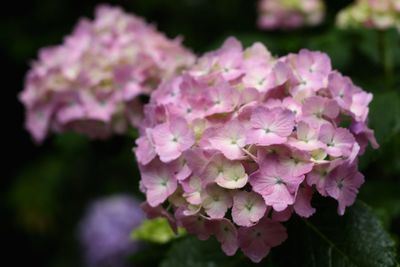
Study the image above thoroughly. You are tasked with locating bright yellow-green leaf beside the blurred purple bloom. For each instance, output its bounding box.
[131,218,186,244]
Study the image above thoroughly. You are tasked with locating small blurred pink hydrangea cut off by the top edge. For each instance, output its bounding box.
[258,0,325,29]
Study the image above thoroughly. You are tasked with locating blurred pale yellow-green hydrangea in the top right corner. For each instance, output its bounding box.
[337,0,400,30]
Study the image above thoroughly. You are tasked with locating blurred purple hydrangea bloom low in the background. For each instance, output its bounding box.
[79,195,145,267]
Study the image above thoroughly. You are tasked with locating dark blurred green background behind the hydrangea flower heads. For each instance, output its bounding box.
[0,0,400,266]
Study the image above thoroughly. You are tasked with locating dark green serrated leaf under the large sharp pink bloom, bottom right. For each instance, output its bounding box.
[274,201,398,267]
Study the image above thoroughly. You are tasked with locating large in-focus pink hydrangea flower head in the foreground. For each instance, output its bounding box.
[135,38,378,262]
